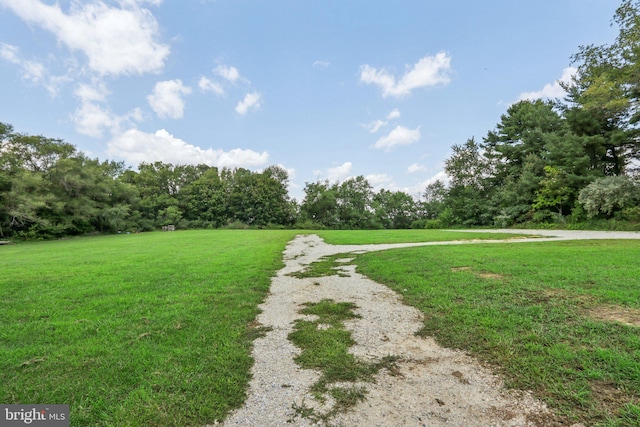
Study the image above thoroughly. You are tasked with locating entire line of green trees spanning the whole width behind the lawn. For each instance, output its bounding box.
[0,0,640,238]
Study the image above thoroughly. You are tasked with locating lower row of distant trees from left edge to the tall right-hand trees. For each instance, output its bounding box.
[0,123,444,239]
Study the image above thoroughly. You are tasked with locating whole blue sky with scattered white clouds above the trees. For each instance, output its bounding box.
[0,0,619,201]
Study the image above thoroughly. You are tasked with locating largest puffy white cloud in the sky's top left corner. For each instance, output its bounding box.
[2,0,170,75]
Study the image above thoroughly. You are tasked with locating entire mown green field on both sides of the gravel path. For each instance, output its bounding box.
[0,230,640,426]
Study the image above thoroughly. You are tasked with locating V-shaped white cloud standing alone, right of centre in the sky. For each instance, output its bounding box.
[360,52,451,97]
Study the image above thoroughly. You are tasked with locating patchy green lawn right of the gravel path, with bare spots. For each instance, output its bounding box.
[356,241,640,426]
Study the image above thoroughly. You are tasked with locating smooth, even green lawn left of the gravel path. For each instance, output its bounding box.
[0,230,296,426]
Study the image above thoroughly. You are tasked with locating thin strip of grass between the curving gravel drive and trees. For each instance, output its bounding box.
[314,230,537,245]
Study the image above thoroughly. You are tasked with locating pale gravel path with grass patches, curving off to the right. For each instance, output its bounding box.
[224,230,640,427]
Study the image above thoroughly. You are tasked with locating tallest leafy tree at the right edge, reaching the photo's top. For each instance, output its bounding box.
[565,0,640,176]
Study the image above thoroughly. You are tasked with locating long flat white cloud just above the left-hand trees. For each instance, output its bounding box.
[107,129,269,168]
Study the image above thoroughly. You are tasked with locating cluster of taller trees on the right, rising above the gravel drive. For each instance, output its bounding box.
[440,0,640,226]
